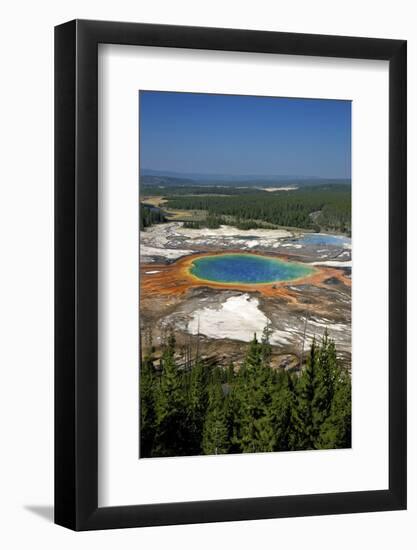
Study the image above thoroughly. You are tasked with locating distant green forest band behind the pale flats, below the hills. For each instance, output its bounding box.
[166,190,351,232]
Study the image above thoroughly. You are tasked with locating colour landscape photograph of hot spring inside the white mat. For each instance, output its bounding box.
[139,91,352,458]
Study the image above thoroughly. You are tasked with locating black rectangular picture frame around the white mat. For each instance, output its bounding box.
[55,20,407,531]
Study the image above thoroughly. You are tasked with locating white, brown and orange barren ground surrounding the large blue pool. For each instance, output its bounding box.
[140,222,351,368]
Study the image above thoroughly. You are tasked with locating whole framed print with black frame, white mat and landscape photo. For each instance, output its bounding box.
[55,20,406,530]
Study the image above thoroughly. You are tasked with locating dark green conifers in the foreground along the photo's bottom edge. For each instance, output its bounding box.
[140,329,351,457]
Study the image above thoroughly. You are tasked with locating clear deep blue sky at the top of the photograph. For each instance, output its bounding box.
[139,91,351,178]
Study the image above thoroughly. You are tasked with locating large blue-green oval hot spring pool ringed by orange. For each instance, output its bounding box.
[190,254,315,284]
